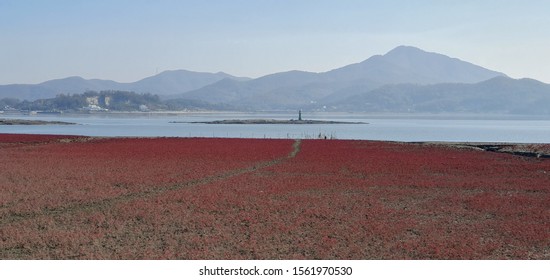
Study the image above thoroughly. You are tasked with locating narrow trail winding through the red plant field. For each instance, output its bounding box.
[0,139,302,226]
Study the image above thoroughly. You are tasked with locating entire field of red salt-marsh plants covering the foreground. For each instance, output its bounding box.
[0,134,550,259]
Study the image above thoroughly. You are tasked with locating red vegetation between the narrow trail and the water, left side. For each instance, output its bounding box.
[0,135,292,215]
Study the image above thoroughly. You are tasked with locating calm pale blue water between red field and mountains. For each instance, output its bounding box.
[0,113,550,143]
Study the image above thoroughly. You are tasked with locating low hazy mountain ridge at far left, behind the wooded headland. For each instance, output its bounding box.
[0,70,248,100]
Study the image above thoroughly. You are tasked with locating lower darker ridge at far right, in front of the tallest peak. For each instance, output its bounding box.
[331,76,550,115]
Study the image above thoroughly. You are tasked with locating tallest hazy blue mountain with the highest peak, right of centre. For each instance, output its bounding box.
[180,46,505,109]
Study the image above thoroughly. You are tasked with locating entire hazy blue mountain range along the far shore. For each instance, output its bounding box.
[0,46,550,114]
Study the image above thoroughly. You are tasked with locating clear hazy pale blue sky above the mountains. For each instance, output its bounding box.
[0,0,550,84]
